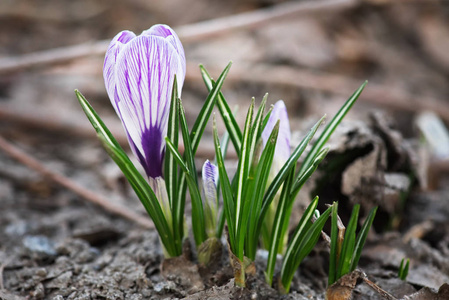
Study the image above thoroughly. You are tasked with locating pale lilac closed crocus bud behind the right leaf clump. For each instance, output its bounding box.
[262,100,291,166]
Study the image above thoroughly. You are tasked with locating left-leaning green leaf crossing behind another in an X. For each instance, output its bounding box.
[200,65,243,156]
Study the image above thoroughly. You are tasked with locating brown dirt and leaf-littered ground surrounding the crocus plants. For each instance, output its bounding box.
[0,0,449,300]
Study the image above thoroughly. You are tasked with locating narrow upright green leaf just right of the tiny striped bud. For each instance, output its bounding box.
[213,118,237,253]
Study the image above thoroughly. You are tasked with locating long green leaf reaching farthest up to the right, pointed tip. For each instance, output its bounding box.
[298,81,368,176]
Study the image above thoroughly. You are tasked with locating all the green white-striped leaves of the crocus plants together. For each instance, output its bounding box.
[76,56,375,293]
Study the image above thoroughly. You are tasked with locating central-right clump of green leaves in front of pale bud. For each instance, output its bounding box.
[201,63,366,292]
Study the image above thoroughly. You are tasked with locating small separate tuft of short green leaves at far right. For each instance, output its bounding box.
[328,203,377,286]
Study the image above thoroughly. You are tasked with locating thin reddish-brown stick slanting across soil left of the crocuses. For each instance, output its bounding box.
[0,136,154,229]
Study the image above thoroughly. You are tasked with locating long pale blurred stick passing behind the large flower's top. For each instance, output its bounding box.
[0,0,360,74]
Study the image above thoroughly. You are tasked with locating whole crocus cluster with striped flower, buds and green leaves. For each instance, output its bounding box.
[76,25,374,292]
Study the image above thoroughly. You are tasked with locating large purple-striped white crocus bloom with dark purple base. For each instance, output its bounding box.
[103,25,186,179]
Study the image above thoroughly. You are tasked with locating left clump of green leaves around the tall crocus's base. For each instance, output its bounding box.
[75,63,231,257]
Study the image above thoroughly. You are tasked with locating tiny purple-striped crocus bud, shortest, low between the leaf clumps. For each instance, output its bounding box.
[202,160,218,237]
